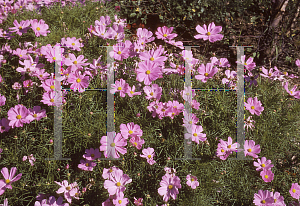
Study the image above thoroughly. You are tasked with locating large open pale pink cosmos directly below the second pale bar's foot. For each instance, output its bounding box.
[104,170,132,196]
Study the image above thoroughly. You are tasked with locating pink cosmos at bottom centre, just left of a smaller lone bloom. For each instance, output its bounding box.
[158,175,181,202]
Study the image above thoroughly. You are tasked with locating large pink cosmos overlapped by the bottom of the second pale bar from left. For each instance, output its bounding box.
[100,132,127,158]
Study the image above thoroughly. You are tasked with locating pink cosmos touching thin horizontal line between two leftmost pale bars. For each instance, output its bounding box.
[68,70,90,93]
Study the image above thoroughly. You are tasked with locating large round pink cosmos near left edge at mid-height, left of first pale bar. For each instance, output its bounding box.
[7,104,30,128]
